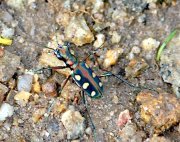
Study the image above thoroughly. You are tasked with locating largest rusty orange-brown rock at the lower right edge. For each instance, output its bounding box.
[136,92,180,134]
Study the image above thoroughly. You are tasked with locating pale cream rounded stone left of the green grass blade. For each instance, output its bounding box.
[141,38,160,52]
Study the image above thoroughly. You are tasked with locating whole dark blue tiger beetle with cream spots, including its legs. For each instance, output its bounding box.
[34,42,154,141]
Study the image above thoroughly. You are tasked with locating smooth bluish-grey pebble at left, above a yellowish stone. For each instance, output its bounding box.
[17,74,33,92]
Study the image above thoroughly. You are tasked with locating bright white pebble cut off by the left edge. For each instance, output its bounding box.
[0,103,14,121]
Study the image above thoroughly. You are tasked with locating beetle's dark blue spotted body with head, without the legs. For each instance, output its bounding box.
[54,44,103,98]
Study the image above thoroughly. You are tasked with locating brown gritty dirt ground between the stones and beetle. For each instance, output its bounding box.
[0,0,180,142]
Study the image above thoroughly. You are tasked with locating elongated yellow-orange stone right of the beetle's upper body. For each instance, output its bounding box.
[103,48,123,68]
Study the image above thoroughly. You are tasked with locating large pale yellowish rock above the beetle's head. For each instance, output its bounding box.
[56,12,94,46]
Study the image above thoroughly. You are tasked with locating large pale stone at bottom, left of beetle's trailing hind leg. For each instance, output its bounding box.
[61,110,85,139]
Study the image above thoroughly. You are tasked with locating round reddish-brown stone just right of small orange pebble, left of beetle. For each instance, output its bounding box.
[42,80,57,97]
